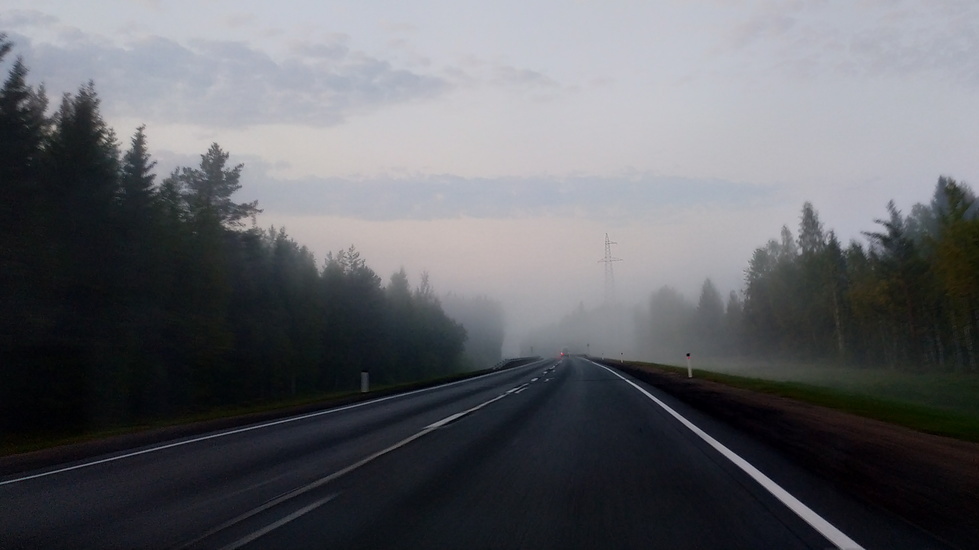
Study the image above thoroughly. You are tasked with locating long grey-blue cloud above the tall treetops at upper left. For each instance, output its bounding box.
[2,25,452,128]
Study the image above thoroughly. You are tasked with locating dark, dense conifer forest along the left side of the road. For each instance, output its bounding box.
[0,35,474,440]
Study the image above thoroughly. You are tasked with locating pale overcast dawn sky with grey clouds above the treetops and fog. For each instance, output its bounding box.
[0,0,979,354]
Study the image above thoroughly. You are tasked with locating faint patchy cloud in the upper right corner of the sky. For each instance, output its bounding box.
[720,0,979,87]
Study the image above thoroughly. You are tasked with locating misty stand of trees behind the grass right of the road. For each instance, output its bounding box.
[637,181,979,373]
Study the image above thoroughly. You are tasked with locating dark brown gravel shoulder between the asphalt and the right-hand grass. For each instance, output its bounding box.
[592,359,979,548]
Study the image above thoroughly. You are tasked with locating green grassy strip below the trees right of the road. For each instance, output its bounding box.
[631,362,979,442]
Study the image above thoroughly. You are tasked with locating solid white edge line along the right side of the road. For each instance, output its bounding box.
[589,361,863,550]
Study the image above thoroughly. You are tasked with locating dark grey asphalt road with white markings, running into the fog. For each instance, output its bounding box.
[0,357,946,549]
